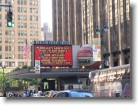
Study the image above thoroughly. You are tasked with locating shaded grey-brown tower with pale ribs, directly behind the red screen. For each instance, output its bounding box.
[52,0,82,45]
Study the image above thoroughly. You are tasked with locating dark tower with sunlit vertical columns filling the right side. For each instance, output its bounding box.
[82,0,132,66]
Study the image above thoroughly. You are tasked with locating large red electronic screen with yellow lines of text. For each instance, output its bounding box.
[34,45,72,67]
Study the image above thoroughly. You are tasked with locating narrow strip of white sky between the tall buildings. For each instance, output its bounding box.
[40,0,52,30]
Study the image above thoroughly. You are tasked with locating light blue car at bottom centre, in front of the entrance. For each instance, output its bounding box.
[54,90,94,98]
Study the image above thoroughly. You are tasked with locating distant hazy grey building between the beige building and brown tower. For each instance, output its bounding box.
[42,23,53,41]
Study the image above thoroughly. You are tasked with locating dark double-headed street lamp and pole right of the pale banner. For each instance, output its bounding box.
[96,22,109,68]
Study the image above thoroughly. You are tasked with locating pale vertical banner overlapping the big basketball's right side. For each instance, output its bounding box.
[93,38,101,61]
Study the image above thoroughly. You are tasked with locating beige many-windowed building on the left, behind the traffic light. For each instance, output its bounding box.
[0,0,41,69]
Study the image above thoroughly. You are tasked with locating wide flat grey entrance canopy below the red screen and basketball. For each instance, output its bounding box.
[5,69,95,78]
